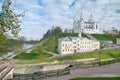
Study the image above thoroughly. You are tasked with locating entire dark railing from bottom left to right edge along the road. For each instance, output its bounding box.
[13,58,120,80]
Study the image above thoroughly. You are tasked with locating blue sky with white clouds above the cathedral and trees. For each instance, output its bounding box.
[5,0,120,40]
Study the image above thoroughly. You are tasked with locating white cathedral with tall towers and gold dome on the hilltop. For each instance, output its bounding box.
[73,13,103,34]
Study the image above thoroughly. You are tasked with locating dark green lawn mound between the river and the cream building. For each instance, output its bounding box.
[14,50,52,60]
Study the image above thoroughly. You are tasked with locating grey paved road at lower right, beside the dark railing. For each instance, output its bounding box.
[47,63,120,80]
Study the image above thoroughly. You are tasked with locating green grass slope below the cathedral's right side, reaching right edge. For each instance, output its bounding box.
[92,34,120,43]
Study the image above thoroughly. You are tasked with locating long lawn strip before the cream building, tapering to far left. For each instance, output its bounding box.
[15,49,120,64]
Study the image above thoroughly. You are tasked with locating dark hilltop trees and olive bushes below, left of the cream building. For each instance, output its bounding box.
[41,26,62,52]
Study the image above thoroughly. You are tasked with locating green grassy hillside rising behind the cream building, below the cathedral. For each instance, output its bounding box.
[43,33,120,53]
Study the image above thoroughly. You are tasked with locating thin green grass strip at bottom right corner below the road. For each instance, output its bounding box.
[70,77,120,80]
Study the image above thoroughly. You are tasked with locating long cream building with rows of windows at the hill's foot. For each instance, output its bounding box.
[58,34,100,54]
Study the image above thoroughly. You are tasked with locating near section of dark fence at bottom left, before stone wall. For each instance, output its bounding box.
[13,69,70,80]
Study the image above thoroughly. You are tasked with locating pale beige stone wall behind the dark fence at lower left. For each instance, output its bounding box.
[14,64,69,74]
